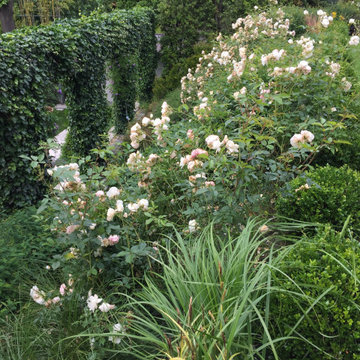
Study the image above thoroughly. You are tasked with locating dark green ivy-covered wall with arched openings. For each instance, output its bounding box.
[0,8,156,208]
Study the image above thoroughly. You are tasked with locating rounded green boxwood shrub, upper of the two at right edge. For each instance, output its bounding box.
[276,166,360,228]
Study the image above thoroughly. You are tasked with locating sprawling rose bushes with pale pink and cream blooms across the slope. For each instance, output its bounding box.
[23,9,355,358]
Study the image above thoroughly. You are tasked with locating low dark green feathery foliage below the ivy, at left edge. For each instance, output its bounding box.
[0,207,57,313]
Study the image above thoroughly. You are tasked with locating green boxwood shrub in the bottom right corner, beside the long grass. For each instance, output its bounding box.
[270,226,360,360]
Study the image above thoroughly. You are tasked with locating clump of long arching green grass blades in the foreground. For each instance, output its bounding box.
[112,220,312,360]
